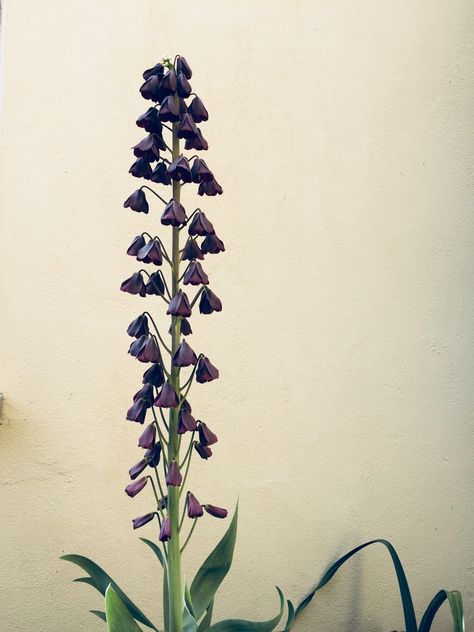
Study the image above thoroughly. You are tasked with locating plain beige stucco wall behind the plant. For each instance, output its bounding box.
[0,0,474,632]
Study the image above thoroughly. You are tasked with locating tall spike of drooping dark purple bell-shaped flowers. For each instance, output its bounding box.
[120,56,227,544]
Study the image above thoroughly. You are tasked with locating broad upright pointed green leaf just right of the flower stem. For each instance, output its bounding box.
[190,505,238,620]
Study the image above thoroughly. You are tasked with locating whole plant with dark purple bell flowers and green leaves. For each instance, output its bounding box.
[64,56,462,632]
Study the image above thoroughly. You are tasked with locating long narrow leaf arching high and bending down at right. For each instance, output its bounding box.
[295,540,418,632]
